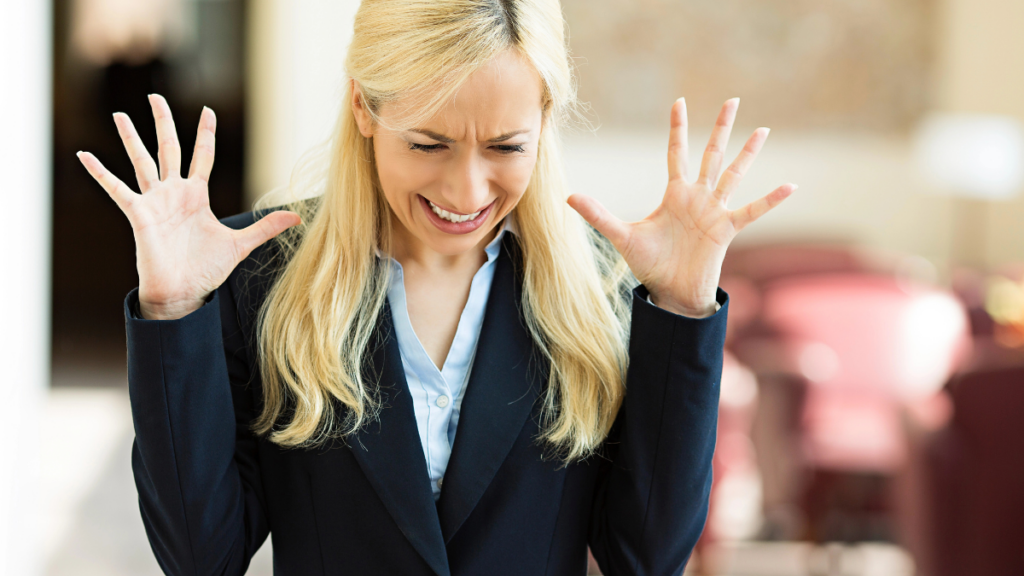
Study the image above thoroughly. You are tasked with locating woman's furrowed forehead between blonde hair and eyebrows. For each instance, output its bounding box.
[389,50,544,140]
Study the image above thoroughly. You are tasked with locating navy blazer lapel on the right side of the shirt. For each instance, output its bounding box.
[437,234,544,543]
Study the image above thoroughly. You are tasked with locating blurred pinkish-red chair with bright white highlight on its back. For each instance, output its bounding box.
[737,274,970,541]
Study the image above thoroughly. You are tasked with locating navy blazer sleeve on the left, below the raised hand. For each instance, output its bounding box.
[125,270,269,575]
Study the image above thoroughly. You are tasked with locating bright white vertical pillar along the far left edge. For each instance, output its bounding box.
[0,1,52,576]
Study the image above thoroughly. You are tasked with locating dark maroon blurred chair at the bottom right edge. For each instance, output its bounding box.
[927,342,1024,576]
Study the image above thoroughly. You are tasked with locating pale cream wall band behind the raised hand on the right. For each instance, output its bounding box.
[566,127,952,273]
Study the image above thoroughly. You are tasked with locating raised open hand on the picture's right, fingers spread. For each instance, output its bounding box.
[568,98,797,318]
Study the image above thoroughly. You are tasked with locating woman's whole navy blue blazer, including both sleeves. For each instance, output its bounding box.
[125,208,728,576]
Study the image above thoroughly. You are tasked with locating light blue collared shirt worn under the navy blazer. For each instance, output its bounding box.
[387,218,514,500]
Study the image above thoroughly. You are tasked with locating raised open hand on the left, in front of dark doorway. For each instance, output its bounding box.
[78,94,300,320]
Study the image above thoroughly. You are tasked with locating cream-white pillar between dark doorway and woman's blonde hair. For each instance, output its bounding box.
[246,0,359,203]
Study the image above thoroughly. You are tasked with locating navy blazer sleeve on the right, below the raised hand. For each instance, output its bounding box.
[589,286,728,576]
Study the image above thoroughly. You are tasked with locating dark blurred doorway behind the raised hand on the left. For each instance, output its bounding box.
[52,0,246,385]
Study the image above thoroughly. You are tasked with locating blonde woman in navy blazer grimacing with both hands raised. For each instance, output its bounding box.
[80,0,795,575]
